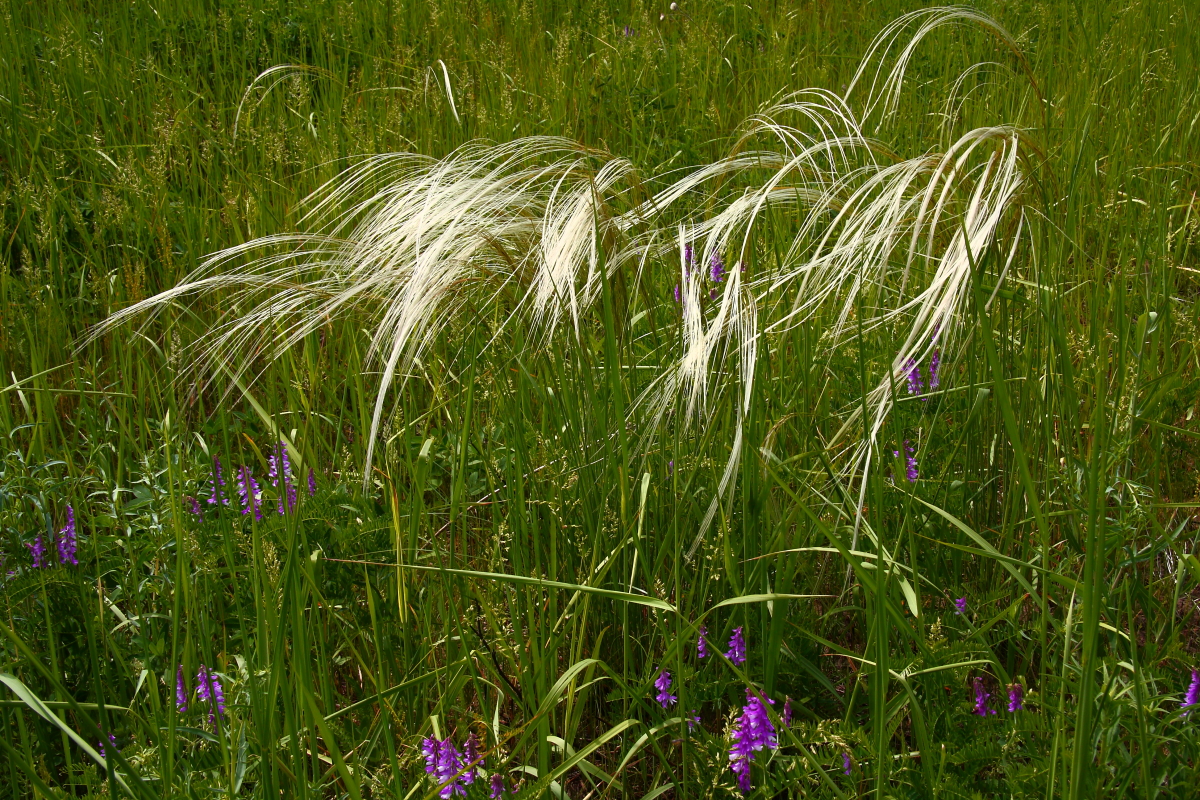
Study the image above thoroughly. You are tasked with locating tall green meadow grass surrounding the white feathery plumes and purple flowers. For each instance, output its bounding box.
[0,0,1200,800]
